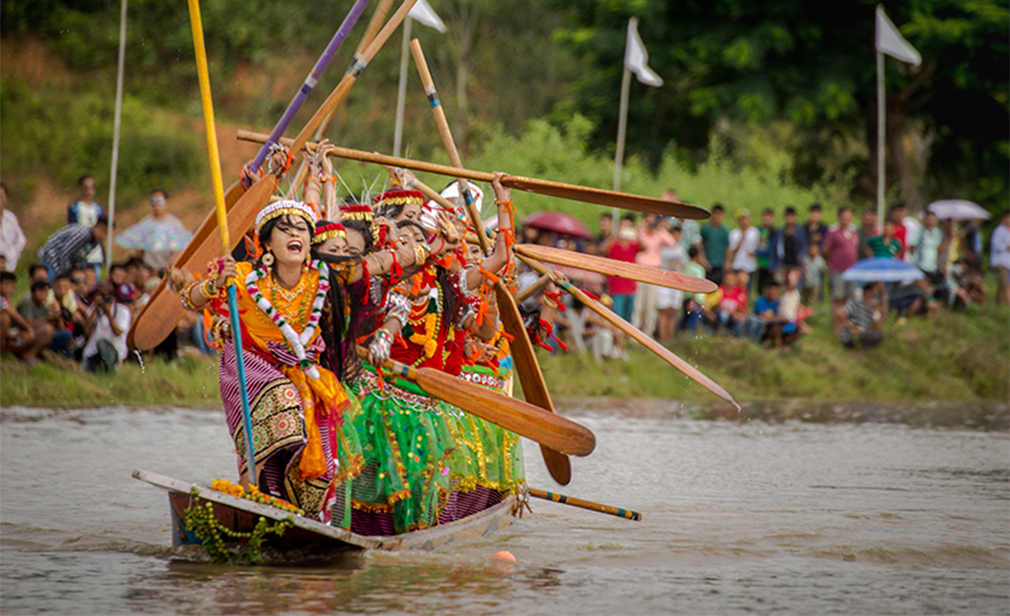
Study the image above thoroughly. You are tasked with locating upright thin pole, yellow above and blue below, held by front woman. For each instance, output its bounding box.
[189,0,258,486]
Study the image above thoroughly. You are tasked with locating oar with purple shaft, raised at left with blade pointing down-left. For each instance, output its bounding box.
[126,0,369,349]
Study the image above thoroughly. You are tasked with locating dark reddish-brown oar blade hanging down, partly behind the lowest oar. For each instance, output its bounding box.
[495,281,572,486]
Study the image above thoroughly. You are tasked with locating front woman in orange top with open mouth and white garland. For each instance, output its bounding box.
[181,179,451,520]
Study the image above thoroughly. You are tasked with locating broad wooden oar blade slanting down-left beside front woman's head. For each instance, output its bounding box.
[127,176,277,350]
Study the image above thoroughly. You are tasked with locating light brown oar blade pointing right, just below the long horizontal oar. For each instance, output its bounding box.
[512,243,718,293]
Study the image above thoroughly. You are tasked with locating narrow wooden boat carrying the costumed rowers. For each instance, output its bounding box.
[133,470,521,554]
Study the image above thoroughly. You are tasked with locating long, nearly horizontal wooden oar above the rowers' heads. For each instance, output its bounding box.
[238,130,709,220]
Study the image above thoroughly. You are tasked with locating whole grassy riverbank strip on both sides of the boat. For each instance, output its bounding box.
[0,306,1010,407]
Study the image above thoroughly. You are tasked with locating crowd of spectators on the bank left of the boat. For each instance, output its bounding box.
[0,175,203,374]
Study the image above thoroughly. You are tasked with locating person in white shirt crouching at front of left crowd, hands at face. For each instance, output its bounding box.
[84,282,130,374]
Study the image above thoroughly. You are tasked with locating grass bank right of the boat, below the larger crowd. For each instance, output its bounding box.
[540,298,1010,402]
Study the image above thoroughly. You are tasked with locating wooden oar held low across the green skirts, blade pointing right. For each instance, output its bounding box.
[358,346,596,455]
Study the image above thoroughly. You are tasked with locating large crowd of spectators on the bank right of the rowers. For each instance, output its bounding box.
[522,191,1010,358]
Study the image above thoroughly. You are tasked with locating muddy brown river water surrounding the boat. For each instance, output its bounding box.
[0,403,1010,614]
